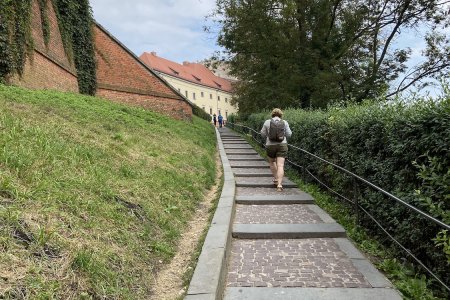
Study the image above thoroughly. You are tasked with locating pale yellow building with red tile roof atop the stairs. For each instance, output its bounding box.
[139,52,237,120]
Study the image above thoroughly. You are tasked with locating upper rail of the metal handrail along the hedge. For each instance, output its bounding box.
[227,122,450,230]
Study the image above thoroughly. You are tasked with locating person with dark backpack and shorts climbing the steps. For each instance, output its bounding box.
[261,108,292,192]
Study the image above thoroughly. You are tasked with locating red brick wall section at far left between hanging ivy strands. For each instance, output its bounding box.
[10,0,78,92]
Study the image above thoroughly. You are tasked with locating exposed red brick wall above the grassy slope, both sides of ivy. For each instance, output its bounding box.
[8,0,192,120]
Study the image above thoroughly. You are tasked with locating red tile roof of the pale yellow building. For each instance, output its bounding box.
[139,52,232,93]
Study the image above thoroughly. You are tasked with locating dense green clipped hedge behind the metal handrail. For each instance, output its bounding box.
[246,94,450,290]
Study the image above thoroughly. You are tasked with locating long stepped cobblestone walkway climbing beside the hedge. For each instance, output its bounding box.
[188,128,401,300]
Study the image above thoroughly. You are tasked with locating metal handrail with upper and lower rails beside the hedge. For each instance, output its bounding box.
[227,122,450,291]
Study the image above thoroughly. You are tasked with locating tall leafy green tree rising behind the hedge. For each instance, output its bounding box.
[212,0,450,114]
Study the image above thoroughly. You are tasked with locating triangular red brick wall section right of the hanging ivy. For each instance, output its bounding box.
[94,26,192,119]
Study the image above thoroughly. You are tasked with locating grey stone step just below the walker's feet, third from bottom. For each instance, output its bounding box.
[235,192,314,205]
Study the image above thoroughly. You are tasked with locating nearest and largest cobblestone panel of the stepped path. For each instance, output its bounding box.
[227,239,371,288]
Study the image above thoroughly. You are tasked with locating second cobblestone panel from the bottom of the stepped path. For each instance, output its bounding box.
[234,204,323,224]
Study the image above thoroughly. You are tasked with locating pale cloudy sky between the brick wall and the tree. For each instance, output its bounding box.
[90,0,218,63]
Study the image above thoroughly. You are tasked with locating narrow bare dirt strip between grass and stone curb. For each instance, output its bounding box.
[152,149,222,300]
